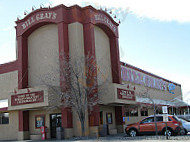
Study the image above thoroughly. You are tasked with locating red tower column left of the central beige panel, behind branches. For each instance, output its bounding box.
[58,22,73,128]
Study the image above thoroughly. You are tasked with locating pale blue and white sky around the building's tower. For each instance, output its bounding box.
[0,0,190,102]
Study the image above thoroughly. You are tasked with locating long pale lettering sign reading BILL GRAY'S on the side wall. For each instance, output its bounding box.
[121,66,167,91]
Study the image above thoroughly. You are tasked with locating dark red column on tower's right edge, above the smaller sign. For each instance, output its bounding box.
[110,37,121,84]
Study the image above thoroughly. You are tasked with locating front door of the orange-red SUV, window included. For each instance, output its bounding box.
[139,117,155,133]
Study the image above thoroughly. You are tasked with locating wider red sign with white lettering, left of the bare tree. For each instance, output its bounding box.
[11,91,44,106]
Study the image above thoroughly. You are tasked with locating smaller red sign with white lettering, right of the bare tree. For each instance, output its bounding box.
[117,88,135,101]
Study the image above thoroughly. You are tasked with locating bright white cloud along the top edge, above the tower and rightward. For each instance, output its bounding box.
[49,0,190,23]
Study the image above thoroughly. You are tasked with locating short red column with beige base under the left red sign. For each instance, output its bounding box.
[18,110,29,140]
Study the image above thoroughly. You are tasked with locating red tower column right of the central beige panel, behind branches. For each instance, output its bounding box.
[83,23,100,126]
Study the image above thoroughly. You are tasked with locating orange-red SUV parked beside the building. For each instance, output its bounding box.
[125,115,182,137]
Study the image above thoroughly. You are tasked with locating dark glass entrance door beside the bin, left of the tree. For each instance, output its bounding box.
[50,113,61,138]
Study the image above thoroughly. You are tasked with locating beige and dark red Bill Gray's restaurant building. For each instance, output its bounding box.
[0,5,185,140]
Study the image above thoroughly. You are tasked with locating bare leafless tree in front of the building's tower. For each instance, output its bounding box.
[43,55,106,136]
